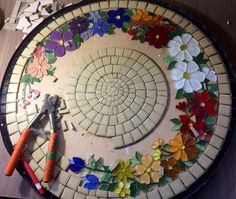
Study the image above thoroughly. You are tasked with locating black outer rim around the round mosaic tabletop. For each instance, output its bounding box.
[0,0,236,199]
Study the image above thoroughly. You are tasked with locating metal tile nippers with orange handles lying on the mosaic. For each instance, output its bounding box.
[4,94,58,182]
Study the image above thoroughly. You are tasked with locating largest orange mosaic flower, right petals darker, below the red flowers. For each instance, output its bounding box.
[168,133,198,162]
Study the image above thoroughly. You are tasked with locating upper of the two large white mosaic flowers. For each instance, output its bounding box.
[168,33,200,61]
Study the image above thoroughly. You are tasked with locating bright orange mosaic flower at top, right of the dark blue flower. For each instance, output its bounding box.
[131,10,153,28]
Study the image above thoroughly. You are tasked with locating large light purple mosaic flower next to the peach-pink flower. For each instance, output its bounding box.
[45,30,76,57]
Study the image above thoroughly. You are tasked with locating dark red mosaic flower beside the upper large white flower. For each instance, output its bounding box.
[145,26,169,48]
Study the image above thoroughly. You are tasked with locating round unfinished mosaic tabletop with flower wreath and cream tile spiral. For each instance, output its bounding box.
[1,0,234,199]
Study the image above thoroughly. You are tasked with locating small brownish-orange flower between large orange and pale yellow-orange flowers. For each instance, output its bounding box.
[161,158,181,180]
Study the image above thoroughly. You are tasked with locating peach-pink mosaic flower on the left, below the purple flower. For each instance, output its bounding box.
[27,56,50,78]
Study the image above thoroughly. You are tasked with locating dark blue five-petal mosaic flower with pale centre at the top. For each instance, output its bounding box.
[107,8,130,28]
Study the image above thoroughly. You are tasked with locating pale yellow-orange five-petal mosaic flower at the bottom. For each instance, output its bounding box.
[135,155,160,184]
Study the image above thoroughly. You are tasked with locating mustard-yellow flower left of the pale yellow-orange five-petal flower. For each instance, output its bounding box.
[112,160,134,183]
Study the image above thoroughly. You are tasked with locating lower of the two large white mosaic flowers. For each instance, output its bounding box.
[171,61,205,93]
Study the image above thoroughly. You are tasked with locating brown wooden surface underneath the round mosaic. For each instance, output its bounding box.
[0,0,236,199]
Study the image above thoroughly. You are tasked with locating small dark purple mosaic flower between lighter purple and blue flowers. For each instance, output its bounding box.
[69,17,89,33]
